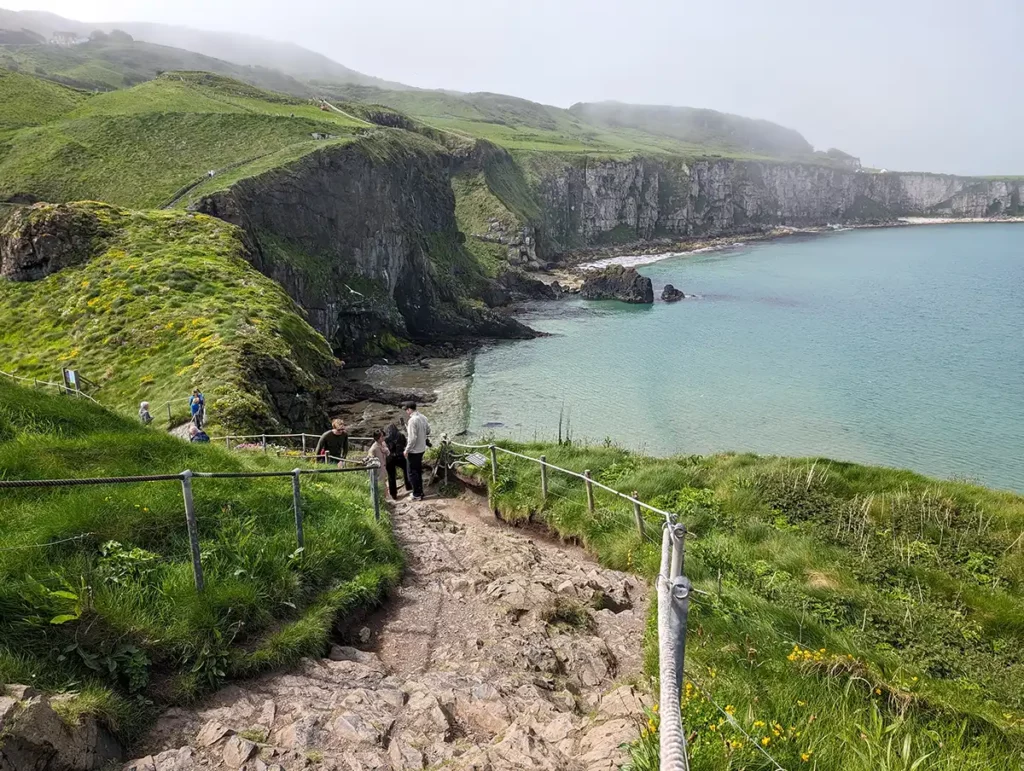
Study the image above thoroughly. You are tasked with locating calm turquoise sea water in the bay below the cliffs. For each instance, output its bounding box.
[469,223,1024,491]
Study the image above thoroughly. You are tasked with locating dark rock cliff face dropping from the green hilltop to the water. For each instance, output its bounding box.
[195,130,531,356]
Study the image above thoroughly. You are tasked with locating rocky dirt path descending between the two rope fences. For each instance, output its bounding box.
[126,498,650,771]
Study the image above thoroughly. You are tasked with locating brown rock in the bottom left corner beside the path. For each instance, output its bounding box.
[0,685,124,771]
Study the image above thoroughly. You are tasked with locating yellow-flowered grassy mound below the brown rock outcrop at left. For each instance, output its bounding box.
[0,204,333,428]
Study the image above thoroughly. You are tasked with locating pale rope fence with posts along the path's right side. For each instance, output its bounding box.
[441,436,694,771]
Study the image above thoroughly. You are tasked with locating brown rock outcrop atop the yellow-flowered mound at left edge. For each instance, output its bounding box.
[0,204,101,282]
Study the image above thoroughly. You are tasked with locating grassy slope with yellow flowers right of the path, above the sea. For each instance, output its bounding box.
[477,445,1024,771]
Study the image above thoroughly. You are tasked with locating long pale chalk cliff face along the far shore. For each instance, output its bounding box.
[535,158,1024,252]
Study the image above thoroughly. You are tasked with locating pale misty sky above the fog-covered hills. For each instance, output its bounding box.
[6,0,1024,174]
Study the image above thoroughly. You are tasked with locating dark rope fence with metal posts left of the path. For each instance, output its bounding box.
[0,461,381,592]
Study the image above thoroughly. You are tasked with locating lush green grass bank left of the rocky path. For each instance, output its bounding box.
[0,382,400,738]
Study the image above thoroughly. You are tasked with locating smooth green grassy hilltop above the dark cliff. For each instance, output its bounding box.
[0,73,364,208]
